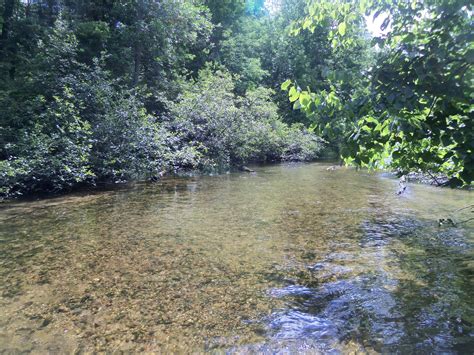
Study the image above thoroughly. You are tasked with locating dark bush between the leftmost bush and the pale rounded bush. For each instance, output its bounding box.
[91,88,167,182]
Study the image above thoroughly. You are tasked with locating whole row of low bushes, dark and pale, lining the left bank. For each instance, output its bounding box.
[0,52,322,200]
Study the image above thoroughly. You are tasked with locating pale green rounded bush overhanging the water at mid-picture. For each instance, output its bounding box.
[168,66,323,170]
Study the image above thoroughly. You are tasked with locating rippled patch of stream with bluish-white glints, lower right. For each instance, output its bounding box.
[268,206,474,353]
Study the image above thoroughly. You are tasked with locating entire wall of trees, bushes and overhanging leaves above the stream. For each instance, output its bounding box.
[0,0,474,196]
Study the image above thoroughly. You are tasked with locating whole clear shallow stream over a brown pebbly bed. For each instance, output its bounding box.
[0,163,474,354]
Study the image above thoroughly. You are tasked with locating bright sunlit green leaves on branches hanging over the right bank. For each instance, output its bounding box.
[283,0,474,185]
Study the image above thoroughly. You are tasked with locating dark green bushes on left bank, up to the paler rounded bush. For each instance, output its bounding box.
[0,23,169,195]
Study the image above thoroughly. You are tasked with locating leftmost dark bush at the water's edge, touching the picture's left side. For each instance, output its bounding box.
[0,88,94,196]
